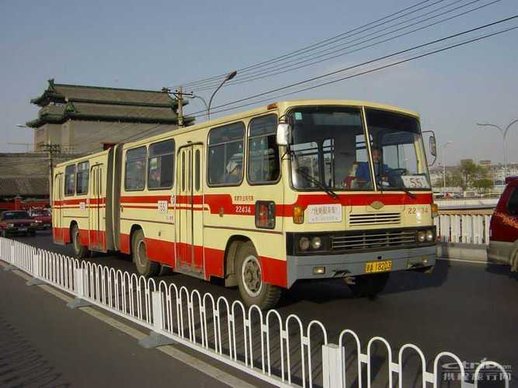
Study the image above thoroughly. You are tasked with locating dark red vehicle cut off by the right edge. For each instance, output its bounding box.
[487,176,518,271]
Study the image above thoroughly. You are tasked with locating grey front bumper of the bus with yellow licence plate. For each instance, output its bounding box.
[287,245,437,288]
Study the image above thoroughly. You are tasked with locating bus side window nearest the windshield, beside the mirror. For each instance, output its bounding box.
[248,115,280,183]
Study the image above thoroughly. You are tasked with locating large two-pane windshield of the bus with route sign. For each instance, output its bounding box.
[289,106,431,192]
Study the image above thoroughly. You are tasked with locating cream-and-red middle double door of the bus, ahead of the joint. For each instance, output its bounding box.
[175,144,203,275]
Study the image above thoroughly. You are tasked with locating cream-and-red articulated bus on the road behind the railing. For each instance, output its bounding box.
[52,100,437,308]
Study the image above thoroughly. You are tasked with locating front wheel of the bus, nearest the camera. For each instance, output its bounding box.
[235,242,281,310]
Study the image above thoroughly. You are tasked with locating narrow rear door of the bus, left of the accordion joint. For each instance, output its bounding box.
[88,164,106,251]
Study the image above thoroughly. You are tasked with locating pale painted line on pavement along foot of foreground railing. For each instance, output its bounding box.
[7,263,255,388]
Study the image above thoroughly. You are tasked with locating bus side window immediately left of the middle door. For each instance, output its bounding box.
[147,140,174,189]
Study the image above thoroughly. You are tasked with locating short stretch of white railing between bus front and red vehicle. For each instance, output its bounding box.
[435,214,491,245]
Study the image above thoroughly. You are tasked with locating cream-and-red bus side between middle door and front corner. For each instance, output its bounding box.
[203,114,287,287]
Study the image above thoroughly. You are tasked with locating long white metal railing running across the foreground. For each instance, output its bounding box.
[0,238,510,388]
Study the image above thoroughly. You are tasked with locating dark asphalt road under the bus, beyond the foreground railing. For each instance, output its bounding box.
[5,230,518,384]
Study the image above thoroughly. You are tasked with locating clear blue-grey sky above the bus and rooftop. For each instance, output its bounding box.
[0,0,518,165]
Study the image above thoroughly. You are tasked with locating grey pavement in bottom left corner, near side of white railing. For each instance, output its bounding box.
[0,236,266,388]
